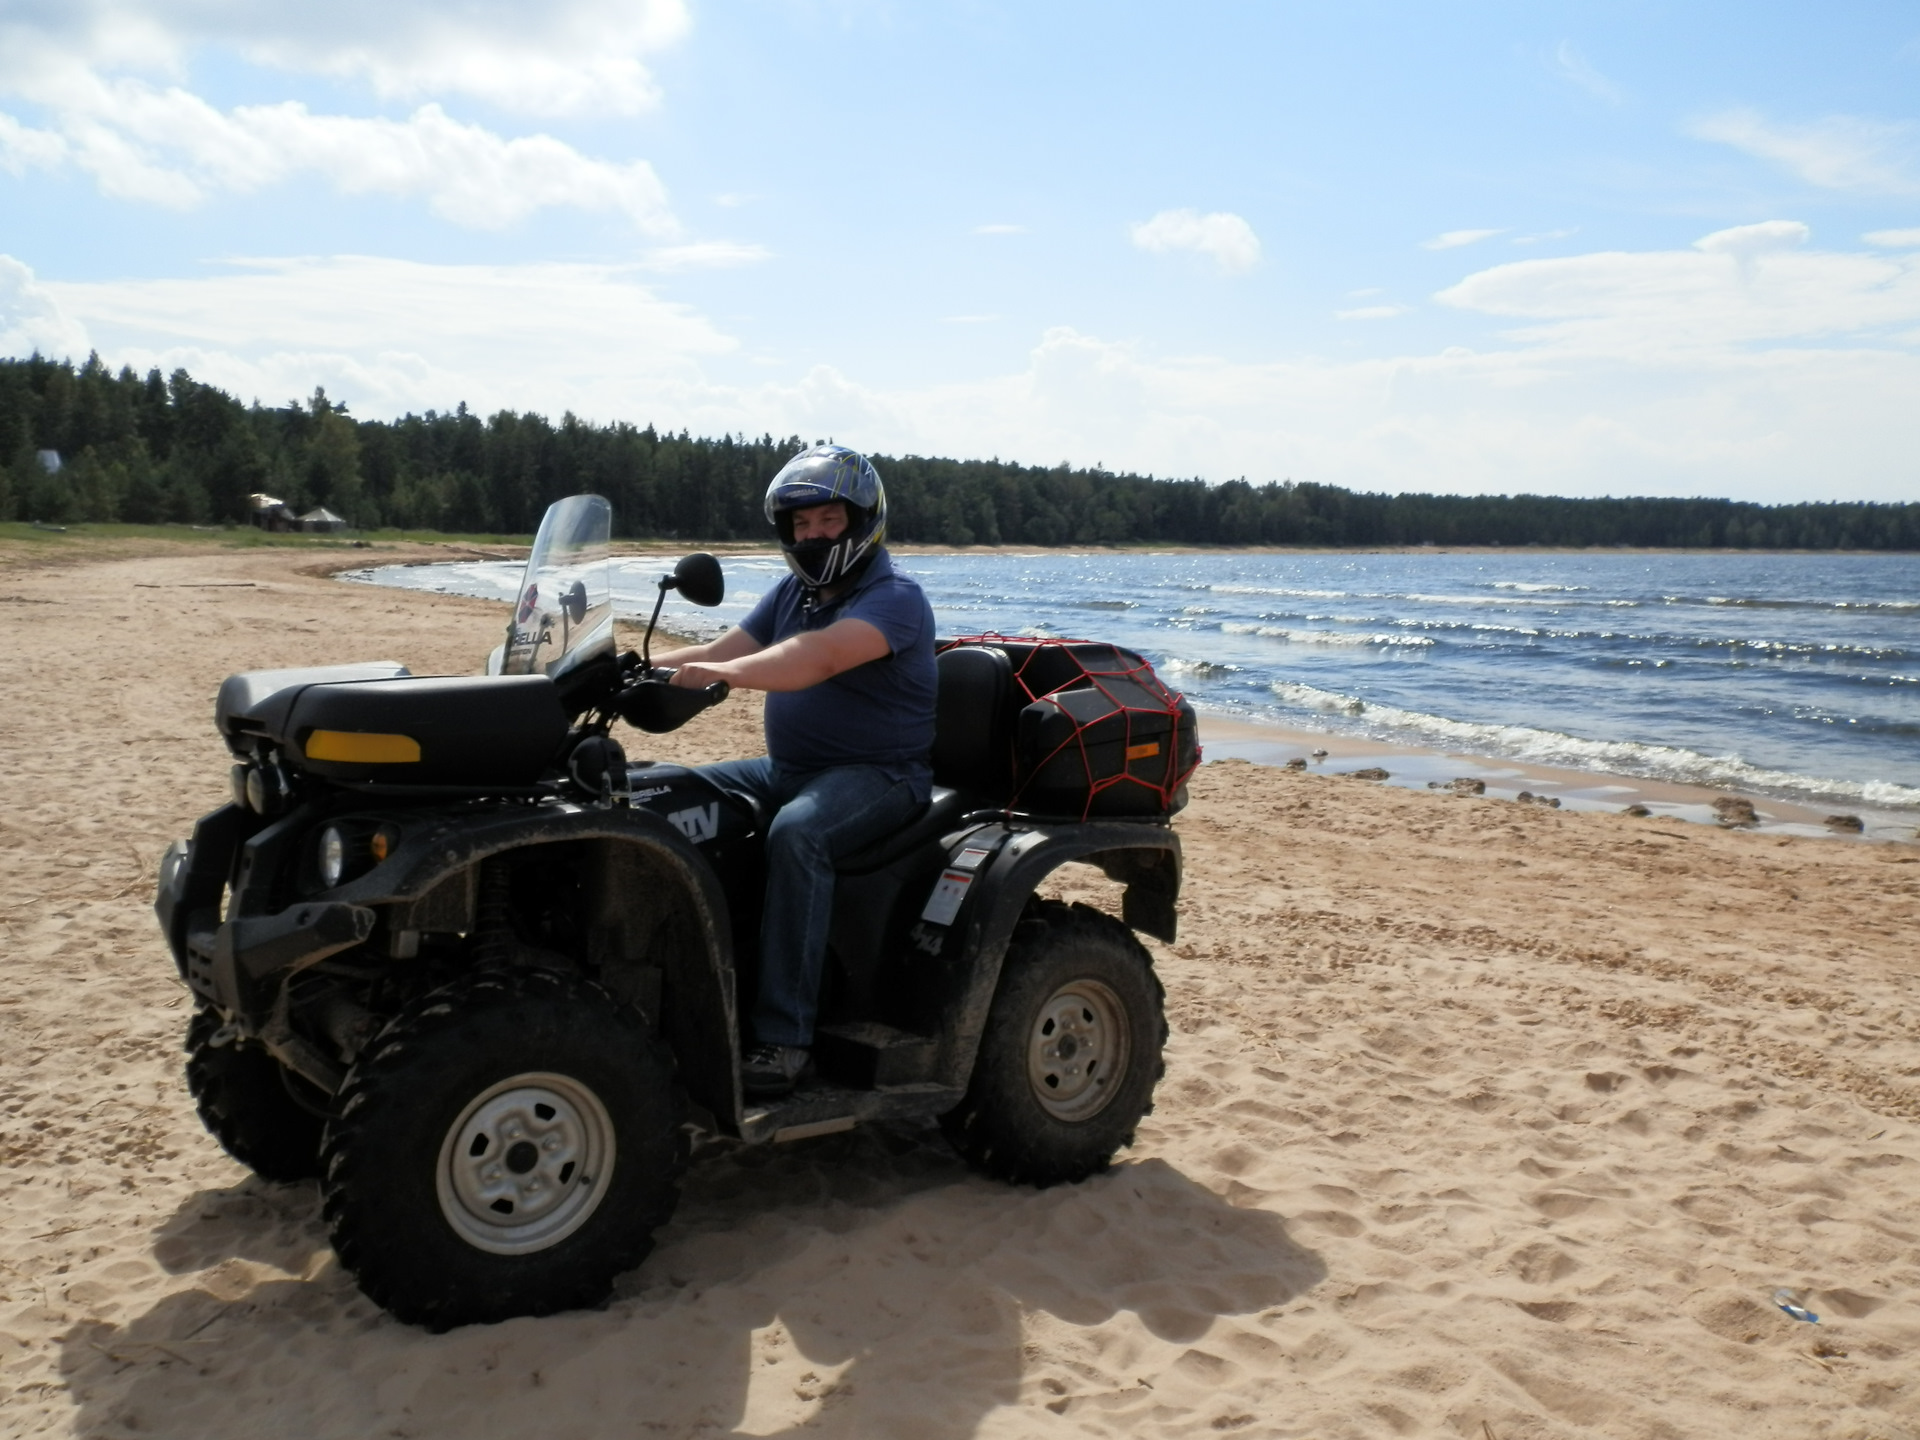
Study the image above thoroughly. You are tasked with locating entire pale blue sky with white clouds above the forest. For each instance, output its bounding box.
[0,0,1920,503]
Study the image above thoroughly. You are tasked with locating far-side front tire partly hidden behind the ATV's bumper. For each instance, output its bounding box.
[186,1010,326,1185]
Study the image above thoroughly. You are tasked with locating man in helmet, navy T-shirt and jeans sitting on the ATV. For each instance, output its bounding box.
[660,445,937,1096]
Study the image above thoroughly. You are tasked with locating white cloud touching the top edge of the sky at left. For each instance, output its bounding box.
[0,0,691,115]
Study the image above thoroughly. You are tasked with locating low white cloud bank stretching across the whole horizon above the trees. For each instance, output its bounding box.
[15,231,1920,499]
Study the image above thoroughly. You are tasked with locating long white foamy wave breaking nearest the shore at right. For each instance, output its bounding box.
[1269,682,1920,808]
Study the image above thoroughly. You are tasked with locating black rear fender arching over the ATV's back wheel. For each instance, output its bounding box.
[937,820,1181,1087]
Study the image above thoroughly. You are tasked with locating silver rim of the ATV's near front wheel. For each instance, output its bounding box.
[434,1071,614,1256]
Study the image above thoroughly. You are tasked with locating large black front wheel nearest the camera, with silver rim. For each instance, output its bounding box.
[323,970,687,1331]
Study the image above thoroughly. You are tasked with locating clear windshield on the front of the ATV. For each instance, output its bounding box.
[488,495,612,676]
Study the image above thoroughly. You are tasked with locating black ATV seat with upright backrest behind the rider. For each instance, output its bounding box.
[833,647,1014,876]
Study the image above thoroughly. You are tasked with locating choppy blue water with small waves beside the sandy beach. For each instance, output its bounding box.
[357,551,1920,810]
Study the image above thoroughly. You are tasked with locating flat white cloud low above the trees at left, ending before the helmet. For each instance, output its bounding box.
[11,255,737,420]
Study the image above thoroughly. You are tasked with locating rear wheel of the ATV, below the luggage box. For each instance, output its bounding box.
[941,900,1167,1187]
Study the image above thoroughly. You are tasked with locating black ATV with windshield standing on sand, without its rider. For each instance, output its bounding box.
[156,495,1192,1329]
